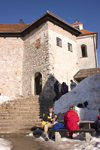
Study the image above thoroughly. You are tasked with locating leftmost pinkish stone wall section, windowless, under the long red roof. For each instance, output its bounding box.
[0,37,23,97]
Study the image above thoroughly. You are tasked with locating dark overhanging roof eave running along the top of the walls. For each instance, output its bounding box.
[0,11,82,37]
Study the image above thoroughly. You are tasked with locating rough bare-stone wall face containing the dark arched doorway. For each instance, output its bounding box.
[22,22,50,99]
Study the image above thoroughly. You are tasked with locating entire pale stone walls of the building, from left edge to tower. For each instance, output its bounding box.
[0,21,95,100]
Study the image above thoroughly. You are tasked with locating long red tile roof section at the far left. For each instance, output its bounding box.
[0,24,30,32]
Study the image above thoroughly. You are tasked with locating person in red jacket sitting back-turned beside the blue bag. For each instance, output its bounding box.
[64,106,79,138]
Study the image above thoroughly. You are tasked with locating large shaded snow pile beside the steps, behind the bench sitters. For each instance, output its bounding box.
[54,74,100,120]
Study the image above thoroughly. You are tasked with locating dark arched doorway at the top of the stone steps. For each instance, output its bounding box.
[35,72,42,95]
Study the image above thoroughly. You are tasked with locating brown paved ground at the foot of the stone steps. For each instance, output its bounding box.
[5,136,57,150]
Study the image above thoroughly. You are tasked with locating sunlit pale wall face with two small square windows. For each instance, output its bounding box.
[48,22,79,90]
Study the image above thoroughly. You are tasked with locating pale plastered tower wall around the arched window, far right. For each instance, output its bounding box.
[77,35,96,69]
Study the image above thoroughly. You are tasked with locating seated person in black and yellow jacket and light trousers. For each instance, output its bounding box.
[42,107,57,141]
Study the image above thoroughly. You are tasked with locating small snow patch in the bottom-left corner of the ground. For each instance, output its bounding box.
[0,138,12,150]
